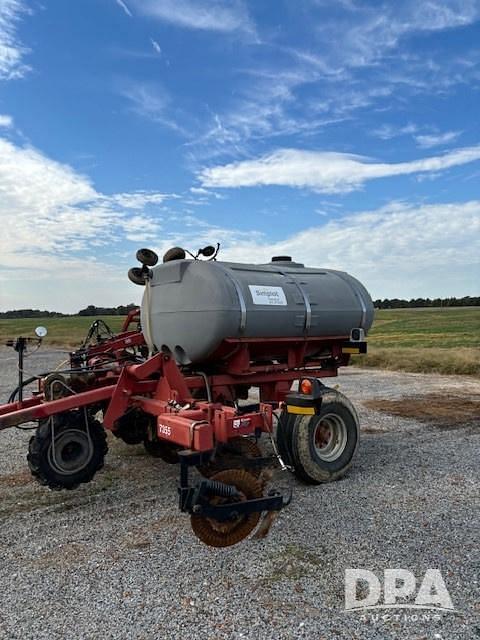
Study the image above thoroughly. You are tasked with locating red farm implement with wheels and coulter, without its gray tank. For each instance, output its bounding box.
[0,248,366,547]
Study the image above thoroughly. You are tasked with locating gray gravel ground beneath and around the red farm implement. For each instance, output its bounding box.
[0,350,480,640]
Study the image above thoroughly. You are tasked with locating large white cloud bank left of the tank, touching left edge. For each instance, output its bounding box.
[0,138,179,311]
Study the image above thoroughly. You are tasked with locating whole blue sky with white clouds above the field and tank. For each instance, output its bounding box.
[0,0,480,311]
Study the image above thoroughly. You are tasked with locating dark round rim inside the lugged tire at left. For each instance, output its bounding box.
[48,429,93,475]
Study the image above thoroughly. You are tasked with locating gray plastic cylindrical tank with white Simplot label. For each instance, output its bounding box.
[141,257,373,364]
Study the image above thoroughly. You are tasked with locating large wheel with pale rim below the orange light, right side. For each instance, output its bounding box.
[277,387,360,484]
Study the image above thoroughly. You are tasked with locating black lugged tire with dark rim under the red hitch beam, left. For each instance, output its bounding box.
[27,411,108,490]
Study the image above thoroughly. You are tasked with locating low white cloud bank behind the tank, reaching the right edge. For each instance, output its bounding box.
[218,201,480,298]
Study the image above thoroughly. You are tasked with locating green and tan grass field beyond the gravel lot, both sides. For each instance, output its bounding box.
[0,307,480,376]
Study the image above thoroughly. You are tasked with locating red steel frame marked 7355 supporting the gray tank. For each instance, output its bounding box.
[0,310,349,451]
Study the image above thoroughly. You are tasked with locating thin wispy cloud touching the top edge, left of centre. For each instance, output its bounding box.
[129,0,254,33]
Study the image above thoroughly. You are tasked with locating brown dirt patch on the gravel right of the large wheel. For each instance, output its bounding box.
[363,393,480,429]
